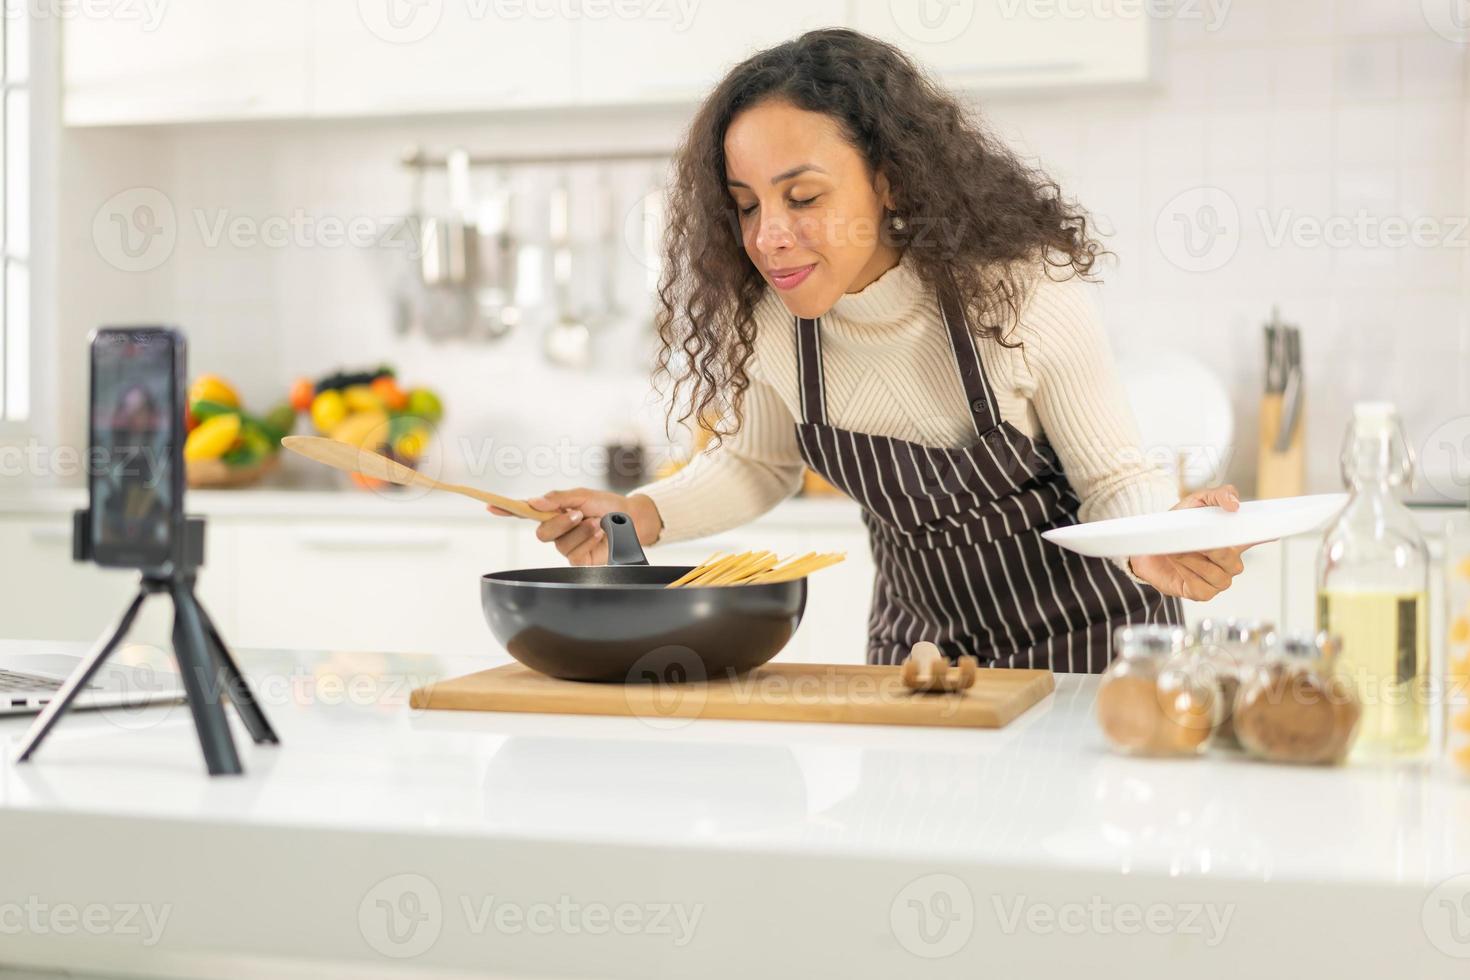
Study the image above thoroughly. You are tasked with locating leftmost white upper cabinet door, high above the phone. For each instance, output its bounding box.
[62,0,310,126]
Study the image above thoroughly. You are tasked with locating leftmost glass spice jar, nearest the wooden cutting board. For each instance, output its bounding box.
[1097,626,1220,755]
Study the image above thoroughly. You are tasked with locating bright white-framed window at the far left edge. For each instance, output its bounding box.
[0,8,31,422]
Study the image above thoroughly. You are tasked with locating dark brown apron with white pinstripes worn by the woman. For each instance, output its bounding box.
[794,279,1183,673]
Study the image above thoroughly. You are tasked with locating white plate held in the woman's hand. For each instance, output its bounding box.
[1041,494,1348,558]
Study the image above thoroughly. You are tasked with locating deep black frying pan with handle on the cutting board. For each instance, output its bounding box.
[479,513,807,680]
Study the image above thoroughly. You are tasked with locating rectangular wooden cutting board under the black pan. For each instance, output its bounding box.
[410,664,1055,729]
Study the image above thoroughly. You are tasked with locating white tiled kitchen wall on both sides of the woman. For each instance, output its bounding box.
[51,0,1470,502]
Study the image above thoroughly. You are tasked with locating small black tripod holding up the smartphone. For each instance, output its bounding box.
[16,510,281,776]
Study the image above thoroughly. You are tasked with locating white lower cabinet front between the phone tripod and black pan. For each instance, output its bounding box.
[232,520,519,654]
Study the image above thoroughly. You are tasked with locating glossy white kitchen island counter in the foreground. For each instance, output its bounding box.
[0,642,1470,979]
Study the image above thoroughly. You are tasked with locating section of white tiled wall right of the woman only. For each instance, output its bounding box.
[988,0,1470,499]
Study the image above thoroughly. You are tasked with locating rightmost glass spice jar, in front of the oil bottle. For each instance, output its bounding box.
[1235,633,1363,764]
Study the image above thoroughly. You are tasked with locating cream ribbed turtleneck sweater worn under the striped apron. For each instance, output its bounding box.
[634,257,1179,572]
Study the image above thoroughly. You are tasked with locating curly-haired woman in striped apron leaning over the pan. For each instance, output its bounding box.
[493,29,1242,671]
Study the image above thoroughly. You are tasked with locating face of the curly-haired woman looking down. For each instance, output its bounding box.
[725,100,898,317]
